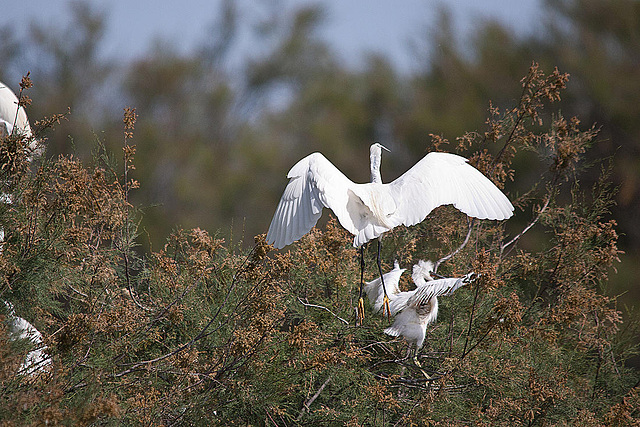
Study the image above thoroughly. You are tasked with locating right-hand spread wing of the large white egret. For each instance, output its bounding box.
[388,152,513,226]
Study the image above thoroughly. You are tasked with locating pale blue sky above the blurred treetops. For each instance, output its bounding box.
[5,0,542,71]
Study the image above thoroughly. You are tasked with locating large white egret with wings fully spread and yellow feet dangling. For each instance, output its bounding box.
[267,143,513,320]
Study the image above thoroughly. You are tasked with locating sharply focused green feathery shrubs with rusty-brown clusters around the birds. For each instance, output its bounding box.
[0,64,640,426]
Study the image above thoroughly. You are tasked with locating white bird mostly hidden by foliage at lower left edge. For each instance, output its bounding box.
[4,301,51,375]
